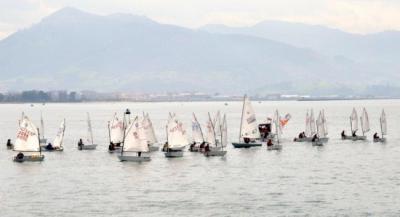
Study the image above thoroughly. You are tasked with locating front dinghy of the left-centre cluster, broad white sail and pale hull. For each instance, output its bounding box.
[118,117,150,162]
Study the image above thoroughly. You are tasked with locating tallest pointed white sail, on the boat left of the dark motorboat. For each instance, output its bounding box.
[240,96,260,139]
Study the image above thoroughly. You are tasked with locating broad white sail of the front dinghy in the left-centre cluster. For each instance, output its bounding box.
[123,117,149,152]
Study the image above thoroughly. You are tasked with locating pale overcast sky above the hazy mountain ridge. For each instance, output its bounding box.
[0,0,400,39]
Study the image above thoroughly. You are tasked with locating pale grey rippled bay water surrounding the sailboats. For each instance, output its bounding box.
[0,100,400,216]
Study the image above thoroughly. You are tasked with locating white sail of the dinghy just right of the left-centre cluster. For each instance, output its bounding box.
[167,115,189,149]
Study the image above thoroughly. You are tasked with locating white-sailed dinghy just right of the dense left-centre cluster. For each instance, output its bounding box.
[164,114,189,158]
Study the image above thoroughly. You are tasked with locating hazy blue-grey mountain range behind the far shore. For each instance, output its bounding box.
[0,8,400,95]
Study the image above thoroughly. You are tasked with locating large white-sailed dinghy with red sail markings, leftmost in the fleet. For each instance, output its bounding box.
[13,116,44,162]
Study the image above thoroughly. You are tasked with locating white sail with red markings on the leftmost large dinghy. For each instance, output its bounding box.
[14,116,40,152]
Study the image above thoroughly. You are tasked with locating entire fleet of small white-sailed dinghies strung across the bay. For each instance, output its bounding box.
[6,96,387,162]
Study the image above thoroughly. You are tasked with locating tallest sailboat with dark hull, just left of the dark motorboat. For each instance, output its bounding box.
[232,95,262,148]
